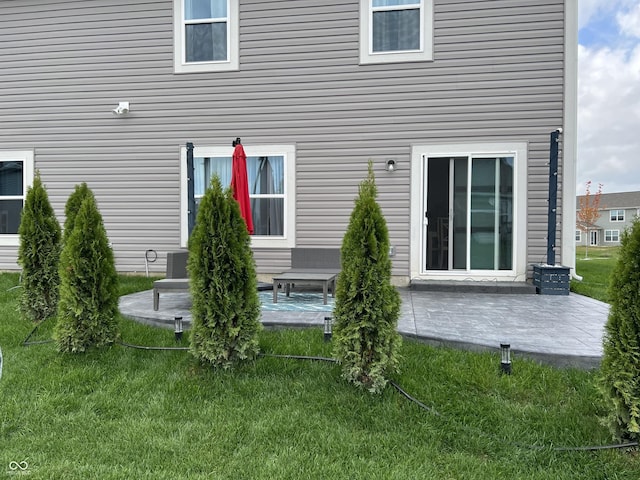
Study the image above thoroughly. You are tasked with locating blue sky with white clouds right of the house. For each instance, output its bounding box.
[576,0,640,195]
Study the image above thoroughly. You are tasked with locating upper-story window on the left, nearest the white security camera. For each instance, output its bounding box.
[173,0,239,73]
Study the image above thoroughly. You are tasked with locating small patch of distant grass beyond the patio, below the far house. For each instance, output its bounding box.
[571,247,620,302]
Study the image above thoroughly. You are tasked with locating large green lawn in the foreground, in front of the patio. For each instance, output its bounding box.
[0,274,640,480]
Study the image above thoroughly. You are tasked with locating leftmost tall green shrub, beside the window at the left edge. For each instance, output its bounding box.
[18,172,61,322]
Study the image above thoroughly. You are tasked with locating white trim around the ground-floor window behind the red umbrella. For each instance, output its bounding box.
[180,145,296,248]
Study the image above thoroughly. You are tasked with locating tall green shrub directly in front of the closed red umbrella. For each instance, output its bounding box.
[187,176,262,368]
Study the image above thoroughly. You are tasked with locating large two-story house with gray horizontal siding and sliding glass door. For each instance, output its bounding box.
[0,0,577,284]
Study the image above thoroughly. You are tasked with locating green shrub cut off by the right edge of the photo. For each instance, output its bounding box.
[600,219,640,440]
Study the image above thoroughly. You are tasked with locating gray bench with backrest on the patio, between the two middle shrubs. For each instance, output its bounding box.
[273,247,341,305]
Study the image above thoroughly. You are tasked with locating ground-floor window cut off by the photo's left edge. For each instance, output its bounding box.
[0,151,33,245]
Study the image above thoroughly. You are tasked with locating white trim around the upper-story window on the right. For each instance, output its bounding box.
[360,0,433,64]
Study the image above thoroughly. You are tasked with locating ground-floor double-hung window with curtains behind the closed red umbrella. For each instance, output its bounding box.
[181,145,295,247]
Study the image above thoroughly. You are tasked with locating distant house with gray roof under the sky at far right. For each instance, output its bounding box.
[576,192,640,247]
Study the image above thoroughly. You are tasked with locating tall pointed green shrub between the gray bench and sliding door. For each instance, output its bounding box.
[333,162,401,393]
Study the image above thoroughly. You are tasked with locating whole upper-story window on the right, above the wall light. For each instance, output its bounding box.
[360,0,433,63]
